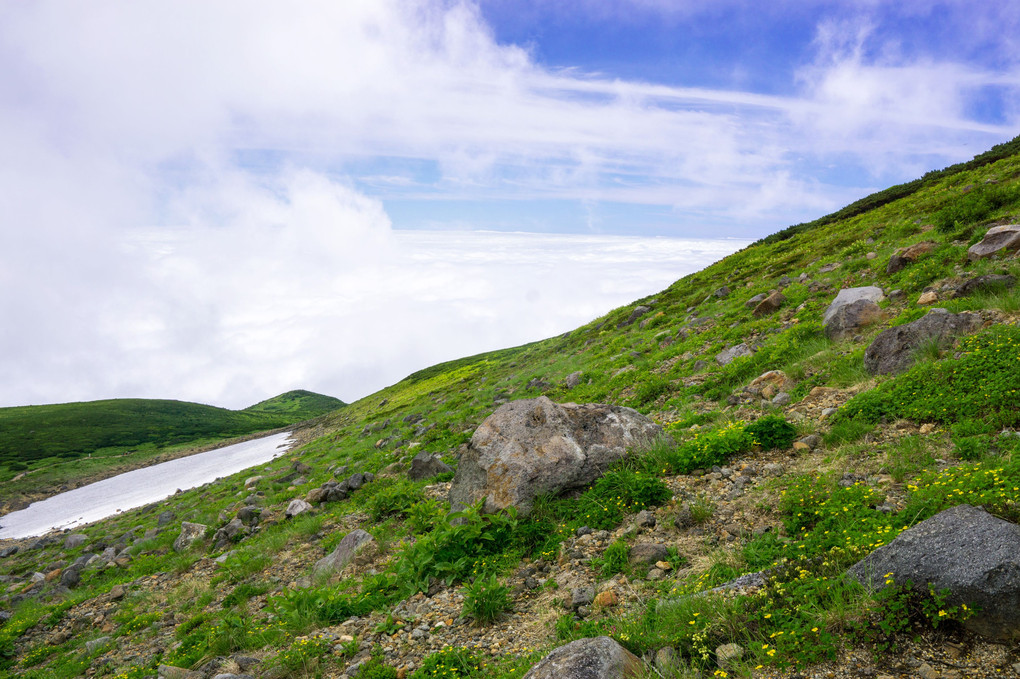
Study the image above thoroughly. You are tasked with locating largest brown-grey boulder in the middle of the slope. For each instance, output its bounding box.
[450,397,664,514]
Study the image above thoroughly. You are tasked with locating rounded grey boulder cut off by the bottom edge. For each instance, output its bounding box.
[524,636,644,679]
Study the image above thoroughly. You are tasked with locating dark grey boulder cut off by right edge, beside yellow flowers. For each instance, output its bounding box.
[850,505,1020,641]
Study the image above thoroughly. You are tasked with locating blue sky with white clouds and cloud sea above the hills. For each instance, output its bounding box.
[0,0,1020,408]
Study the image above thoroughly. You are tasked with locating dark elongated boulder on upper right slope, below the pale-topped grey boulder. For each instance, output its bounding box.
[864,308,982,375]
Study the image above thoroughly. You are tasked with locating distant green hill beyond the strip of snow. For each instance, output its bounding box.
[0,390,344,466]
